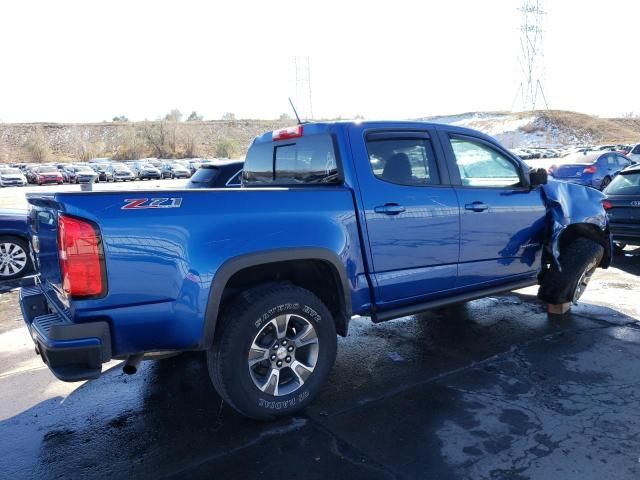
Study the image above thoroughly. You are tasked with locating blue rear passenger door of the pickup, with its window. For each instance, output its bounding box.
[349,125,460,306]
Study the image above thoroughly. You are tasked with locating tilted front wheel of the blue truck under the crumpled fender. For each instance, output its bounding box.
[538,237,604,304]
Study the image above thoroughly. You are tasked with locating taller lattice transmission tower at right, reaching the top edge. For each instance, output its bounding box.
[516,0,549,110]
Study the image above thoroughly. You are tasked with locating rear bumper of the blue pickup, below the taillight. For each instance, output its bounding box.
[19,285,111,382]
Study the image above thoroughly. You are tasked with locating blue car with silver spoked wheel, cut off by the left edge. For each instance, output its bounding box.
[0,209,33,280]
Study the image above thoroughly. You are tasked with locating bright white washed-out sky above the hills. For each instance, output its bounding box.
[0,0,640,122]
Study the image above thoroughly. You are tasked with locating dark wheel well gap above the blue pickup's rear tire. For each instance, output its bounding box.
[218,259,350,336]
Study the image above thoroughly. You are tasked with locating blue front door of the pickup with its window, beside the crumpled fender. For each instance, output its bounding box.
[440,131,546,287]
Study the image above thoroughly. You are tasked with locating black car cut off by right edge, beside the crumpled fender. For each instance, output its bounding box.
[602,165,640,251]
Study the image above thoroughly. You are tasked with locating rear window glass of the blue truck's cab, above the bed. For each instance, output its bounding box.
[243,135,339,185]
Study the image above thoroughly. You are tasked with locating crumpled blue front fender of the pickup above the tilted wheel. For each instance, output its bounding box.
[542,179,613,269]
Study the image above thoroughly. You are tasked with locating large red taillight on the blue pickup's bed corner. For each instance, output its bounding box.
[58,215,106,298]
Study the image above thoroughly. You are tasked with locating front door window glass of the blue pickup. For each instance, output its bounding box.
[451,138,520,188]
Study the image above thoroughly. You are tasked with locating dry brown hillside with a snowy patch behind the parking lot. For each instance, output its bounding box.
[0,110,640,163]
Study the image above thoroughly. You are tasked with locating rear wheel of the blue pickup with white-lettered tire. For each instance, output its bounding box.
[207,283,337,420]
